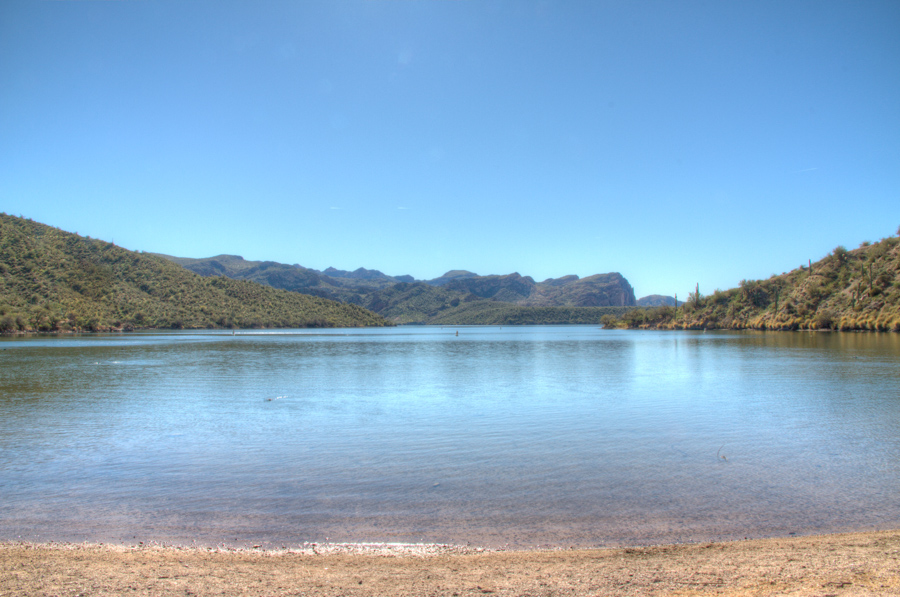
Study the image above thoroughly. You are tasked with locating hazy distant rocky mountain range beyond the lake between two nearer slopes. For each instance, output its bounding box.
[158,254,648,324]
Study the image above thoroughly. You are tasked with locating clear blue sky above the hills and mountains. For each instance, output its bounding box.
[0,0,900,297]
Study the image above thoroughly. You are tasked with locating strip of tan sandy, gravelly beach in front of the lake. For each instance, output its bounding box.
[0,531,900,597]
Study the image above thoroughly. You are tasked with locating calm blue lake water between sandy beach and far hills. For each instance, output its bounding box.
[0,326,900,547]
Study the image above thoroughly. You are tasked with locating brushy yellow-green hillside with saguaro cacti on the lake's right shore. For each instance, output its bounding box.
[602,230,900,332]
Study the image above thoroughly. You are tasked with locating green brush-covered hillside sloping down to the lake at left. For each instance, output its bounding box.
[0,214,386,332]
